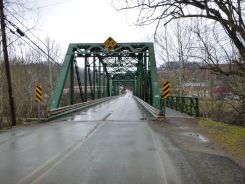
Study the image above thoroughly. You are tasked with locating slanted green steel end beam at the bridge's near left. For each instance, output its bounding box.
[50,44,74,109]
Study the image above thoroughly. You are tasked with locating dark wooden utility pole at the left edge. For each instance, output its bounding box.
[0,0,16,126]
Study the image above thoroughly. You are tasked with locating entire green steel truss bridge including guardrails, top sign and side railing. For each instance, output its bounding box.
[49,38,198,119]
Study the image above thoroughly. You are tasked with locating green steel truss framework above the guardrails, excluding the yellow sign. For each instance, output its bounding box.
[50,42,160,109]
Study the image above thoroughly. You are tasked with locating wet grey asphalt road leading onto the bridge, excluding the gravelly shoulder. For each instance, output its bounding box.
[0,95,178,184]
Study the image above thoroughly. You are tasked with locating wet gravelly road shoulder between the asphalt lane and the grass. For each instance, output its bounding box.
[148,118,245,184]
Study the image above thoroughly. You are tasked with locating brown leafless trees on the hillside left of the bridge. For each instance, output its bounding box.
[0,50,59,126]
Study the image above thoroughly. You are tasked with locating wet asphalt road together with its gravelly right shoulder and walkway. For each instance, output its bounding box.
[0,94,245,184]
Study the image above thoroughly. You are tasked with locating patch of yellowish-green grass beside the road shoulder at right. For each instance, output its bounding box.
[199,119,245,165]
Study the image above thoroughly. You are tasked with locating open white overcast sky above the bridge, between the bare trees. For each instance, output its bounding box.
[14,0,152,56]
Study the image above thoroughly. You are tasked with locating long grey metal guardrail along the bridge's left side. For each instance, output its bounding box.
[48,96,117,121]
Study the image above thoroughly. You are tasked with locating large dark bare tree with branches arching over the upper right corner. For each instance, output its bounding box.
[115,0,245,77]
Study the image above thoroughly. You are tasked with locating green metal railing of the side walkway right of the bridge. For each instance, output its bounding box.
[166,96,199,117]
